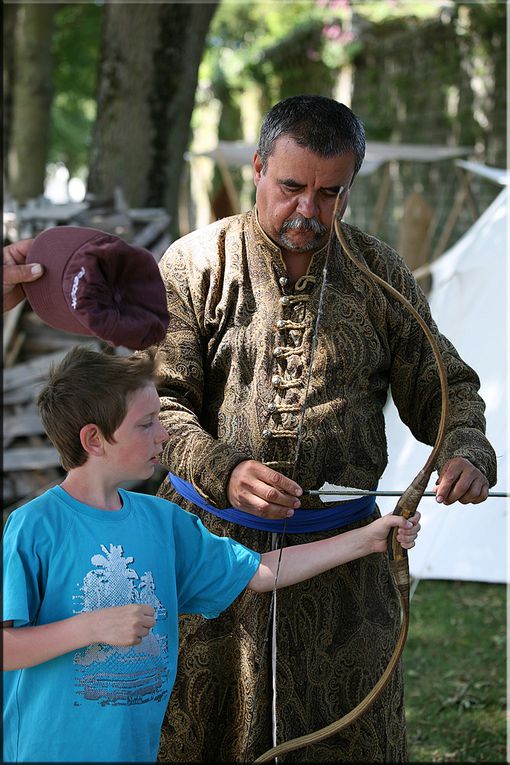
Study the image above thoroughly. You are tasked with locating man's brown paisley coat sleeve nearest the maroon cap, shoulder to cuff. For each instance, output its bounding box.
[158,245,249,507]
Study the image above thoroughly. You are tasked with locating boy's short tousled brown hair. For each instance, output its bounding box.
[37,345,158,470]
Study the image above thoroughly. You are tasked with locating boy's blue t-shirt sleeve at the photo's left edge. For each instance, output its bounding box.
[2,512,41,627]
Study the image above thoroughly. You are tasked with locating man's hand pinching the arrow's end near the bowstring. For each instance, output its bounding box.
[227,460,303,519]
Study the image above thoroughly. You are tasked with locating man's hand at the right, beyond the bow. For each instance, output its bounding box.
[434,457,489,505]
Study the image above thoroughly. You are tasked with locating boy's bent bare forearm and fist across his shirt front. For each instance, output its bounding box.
[3,604,156,671]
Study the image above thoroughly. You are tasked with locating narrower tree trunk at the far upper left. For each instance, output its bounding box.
[7,3,57,204]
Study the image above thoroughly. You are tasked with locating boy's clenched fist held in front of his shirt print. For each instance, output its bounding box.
[89,603,156,645]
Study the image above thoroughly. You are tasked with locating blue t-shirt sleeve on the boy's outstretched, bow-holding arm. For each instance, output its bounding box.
[174,508,260,619]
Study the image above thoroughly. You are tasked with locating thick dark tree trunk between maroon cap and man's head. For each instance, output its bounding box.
[88,2,217,237]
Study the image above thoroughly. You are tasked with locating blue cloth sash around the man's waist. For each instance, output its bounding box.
[167,473,375,534]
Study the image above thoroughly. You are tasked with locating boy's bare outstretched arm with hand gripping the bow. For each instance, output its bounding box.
[248,512,420,592]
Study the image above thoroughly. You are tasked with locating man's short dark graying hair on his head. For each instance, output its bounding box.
[257,95,366,177]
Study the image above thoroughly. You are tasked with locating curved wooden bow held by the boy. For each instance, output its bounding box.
[254,212,448,762]
